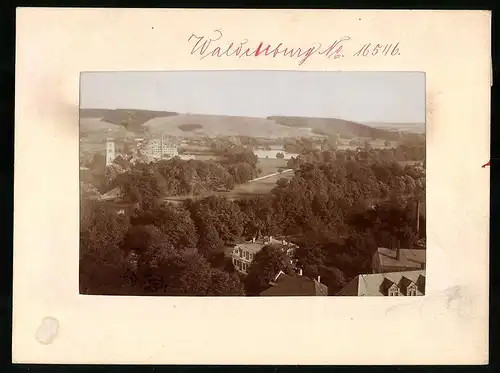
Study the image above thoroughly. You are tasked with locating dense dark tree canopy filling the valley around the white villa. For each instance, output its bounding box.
[80,142,425,296]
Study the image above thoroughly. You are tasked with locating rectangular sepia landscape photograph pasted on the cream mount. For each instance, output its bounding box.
[79,70,426,297]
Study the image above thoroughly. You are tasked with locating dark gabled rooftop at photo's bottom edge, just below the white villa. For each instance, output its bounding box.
[260,274,328,296]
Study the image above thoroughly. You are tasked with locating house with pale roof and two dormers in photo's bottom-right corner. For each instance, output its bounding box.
[336,271,425,296]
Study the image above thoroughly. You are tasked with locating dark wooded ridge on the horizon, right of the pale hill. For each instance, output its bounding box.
[267,116,399,140]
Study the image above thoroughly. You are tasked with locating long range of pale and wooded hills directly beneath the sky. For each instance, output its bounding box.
[80,109,422,141]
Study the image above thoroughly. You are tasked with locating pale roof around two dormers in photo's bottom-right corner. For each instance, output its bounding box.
[337,271,425,296]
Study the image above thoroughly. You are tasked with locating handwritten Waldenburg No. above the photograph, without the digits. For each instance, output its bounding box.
[188,30,351,65]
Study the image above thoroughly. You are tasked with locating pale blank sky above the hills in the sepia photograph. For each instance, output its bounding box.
[80,71,426,123]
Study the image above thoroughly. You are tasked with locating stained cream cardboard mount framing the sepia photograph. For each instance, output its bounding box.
[13,8,491,365]
